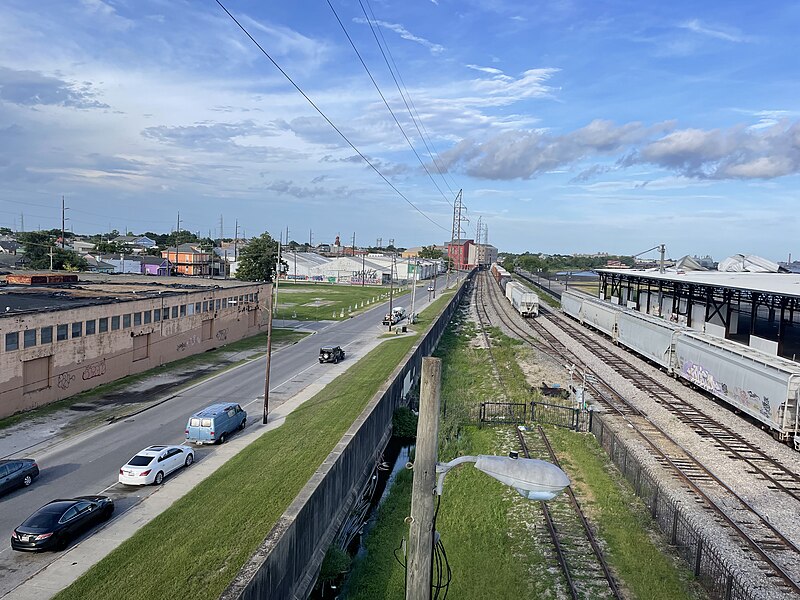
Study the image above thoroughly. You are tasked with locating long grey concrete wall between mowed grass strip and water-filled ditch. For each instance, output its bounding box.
[220,272,466,600]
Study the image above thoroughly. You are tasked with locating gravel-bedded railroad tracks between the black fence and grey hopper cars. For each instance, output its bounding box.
[483,275,800,594]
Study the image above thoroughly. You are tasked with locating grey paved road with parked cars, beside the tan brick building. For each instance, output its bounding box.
[0,277,462,596]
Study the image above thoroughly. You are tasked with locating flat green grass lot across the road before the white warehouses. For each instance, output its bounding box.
[275,283,406,321]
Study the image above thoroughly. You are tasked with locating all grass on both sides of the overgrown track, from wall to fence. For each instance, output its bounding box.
[346,308,695,600]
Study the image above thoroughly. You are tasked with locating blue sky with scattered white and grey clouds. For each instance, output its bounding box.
[0,0,800,260]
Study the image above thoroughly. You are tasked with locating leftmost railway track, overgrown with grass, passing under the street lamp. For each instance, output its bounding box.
[475,277,622,600]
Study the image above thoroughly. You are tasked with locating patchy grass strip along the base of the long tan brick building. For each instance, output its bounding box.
[0,329,308,431]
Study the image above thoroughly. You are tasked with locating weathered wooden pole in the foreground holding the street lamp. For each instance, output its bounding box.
[406,356,442,600]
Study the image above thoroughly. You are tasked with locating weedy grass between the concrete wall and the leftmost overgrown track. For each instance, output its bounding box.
[346,312,555,600]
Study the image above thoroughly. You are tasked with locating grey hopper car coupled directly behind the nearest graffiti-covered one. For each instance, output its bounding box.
[617,310,686,373]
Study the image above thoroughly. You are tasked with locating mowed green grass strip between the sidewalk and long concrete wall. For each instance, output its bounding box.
[56,294,451,600]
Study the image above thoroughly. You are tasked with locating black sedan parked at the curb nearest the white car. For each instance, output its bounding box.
[11,496,114,552]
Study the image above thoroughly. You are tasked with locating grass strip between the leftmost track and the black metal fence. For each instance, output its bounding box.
[547,429,705,600]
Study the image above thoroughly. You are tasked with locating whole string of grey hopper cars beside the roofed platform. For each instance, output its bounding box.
[561,291,800,442]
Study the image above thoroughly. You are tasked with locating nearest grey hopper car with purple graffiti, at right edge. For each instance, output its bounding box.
[675,331,800,440]
